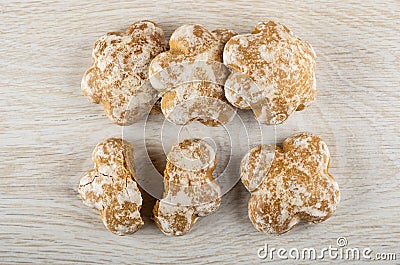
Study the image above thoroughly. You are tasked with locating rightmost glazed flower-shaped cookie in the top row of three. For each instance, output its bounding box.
[223,21,316,124]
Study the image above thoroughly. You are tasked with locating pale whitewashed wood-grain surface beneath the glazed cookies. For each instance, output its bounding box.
[0,0,400,264]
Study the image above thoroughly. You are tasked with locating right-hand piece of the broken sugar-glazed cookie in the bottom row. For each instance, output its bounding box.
[153,139,221,235]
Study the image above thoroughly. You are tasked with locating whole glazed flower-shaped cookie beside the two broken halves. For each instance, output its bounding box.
[241,133,340,234]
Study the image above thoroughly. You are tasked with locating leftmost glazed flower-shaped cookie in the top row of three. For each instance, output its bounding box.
[81,21,164,125]
